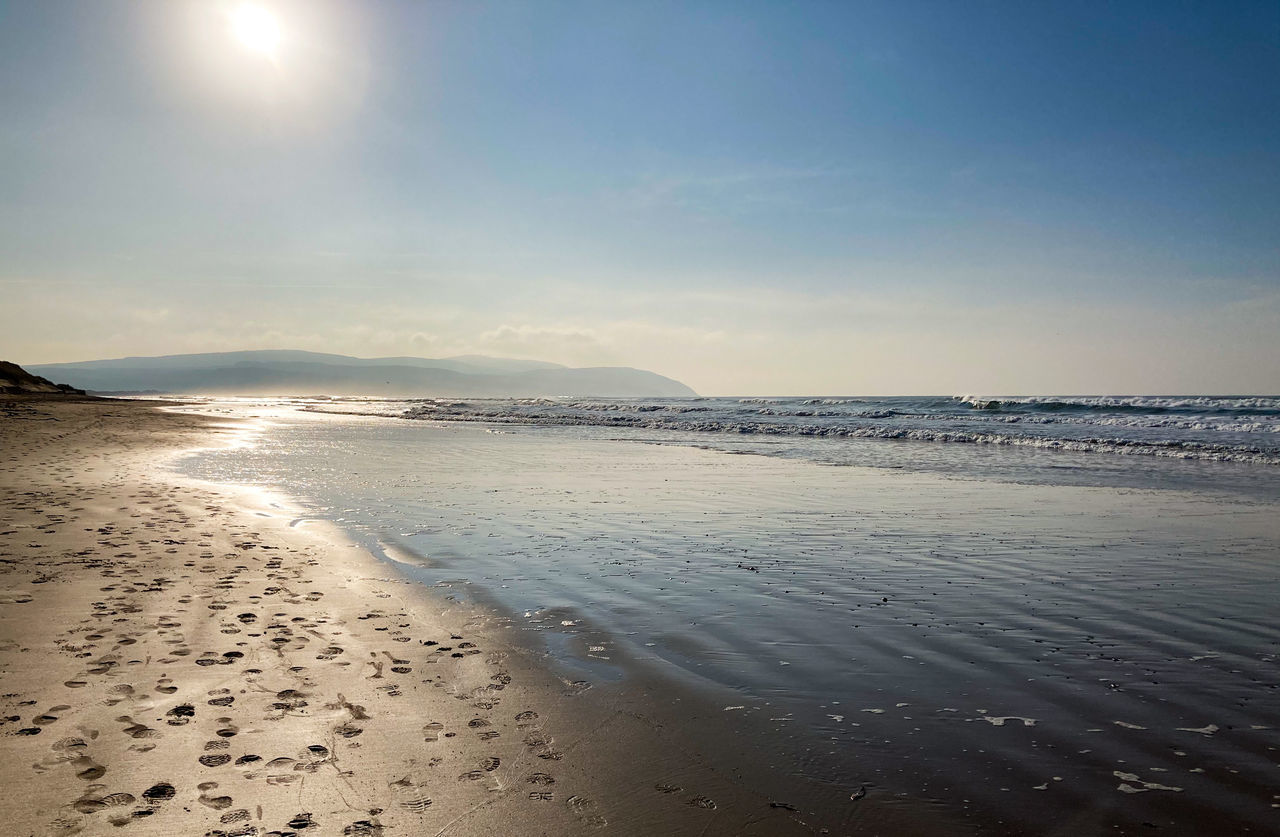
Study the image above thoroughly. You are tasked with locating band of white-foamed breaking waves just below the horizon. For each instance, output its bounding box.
[386,395,1280,466]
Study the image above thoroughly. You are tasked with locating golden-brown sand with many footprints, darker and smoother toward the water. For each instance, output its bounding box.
[0,397,900,834]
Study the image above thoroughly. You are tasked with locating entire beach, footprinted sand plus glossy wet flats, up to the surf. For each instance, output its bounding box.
[0,395,1275,837]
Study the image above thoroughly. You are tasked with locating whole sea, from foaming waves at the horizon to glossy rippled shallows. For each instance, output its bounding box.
[179,395,1280,834]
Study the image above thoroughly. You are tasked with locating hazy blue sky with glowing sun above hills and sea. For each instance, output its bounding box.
[0,0,1280,394]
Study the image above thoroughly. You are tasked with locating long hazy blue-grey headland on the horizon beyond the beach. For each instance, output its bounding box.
[29,349,696,398]
